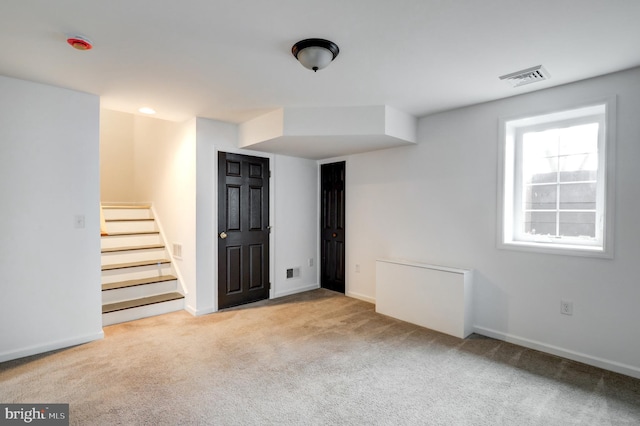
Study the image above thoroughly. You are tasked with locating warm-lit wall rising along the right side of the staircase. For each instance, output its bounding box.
[133,116,197,306]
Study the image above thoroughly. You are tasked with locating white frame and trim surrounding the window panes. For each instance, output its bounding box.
[498,97,616,258]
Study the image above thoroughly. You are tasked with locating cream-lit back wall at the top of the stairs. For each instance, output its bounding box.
[100,109,137,202]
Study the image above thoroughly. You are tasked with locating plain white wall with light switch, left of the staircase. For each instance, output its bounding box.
[0,76,103,362]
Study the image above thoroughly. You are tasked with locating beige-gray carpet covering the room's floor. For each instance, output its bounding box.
[0,289,640,426]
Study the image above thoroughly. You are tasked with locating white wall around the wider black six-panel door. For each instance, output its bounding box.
[190,118,318,315]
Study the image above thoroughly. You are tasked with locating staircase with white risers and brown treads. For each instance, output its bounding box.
[101,203,184,326]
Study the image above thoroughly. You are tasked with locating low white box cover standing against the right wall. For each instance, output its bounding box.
[376,259,473,339]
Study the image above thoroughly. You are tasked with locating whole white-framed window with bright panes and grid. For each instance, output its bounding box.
[499,102,613,257]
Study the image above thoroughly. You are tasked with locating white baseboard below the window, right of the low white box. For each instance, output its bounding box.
[473,325,640,379]
